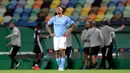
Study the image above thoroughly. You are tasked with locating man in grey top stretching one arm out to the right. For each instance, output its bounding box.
[100,20,125,69]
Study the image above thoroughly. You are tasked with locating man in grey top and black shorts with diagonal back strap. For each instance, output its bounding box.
[86,22,104,68]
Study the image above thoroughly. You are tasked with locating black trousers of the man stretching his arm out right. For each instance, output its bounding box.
[100,43,113,69]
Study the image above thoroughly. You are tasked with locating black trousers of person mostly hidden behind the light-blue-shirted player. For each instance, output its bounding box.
[65,46,72,69]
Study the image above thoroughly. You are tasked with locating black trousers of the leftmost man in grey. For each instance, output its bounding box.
[9,45,20,69]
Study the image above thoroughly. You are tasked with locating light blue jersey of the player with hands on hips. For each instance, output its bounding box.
[48,15,74,37]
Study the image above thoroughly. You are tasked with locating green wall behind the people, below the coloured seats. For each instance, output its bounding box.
[0,27,130,69]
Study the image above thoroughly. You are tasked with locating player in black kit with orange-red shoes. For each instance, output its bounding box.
[32,23,50,70]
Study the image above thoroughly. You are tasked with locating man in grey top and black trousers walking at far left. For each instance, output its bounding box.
[5,23,21,69]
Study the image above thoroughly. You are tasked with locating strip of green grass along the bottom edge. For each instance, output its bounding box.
[0,70,130,73]
